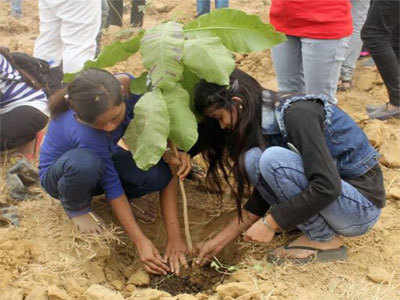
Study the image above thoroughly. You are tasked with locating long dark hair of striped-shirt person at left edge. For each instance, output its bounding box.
[0,47,51,96]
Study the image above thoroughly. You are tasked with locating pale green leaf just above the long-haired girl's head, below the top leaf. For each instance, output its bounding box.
[183,37,235,85]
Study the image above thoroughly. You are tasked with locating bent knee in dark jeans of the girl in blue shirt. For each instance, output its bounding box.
[65,149,104,186]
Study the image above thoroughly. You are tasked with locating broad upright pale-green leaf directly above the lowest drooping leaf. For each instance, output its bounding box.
[140,22,184,89]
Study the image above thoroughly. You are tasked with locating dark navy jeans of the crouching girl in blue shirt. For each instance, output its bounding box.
[41,149,172,217]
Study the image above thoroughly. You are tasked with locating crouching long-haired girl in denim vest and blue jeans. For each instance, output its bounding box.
[195,70,385,265]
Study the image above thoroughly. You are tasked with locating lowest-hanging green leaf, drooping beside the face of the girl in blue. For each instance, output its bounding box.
[124,89,169,170]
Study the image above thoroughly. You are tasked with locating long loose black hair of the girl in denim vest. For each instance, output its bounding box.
[195,69,272,219]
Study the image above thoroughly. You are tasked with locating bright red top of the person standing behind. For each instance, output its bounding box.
[269,0,353,39]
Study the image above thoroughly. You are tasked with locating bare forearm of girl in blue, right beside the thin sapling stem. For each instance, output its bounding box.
[160,176,181,241]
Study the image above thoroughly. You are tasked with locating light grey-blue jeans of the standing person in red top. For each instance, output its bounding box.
[272,36,346,103]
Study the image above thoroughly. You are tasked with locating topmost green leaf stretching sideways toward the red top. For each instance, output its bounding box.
[184,9,286,53]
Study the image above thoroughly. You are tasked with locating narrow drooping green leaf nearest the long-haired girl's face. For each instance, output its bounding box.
[163,84,198,151]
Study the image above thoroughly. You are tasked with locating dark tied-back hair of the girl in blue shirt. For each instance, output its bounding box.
[49,68,122,124]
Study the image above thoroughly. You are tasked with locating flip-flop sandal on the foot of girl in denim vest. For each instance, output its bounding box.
[267,245,347,265]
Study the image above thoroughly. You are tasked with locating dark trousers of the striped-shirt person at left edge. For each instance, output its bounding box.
[0,105,48,151]
